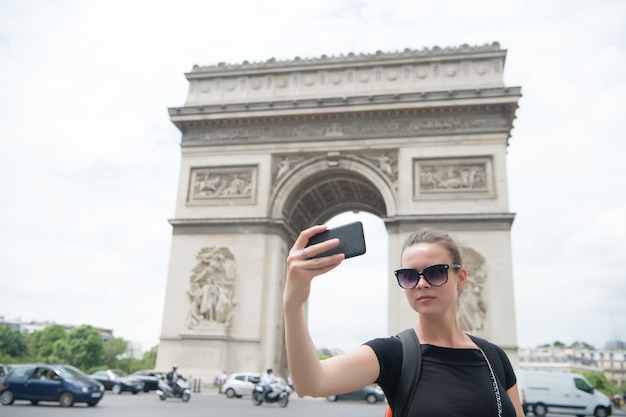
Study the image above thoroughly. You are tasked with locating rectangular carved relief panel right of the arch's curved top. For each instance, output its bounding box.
[413,157,495,199]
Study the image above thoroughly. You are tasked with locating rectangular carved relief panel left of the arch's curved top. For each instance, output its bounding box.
[187,166,257,205]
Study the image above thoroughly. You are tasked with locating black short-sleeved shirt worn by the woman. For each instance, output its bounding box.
[366,338,516,417]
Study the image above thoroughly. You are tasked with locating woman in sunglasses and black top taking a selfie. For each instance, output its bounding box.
[283,225,524,417]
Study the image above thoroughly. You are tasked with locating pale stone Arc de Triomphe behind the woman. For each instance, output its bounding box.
[157,43,521,378]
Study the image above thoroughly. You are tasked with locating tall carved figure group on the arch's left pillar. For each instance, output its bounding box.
[187,246,236,329]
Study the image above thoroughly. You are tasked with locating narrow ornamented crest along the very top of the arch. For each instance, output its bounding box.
[186,42,506,75]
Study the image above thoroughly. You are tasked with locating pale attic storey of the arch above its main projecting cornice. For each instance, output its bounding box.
[178,42,506,107]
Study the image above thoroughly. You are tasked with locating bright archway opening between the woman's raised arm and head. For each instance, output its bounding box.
[308,211,392,353]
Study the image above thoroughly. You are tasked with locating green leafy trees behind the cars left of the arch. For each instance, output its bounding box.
[0,324,157,373]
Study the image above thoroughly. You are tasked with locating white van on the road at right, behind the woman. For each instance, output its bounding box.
[516,369,612,417]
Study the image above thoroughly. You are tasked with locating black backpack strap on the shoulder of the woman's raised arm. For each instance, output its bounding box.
[392,328,422,417]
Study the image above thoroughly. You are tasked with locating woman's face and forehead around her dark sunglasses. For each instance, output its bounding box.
[401,243,467,317]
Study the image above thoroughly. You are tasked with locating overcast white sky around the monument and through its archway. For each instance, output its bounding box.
[0,0,626,350]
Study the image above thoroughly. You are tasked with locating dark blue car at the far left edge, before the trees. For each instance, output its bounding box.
[0,364,104,407]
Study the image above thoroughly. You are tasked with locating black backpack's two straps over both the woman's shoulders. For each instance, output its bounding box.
[386,328,505,417]
